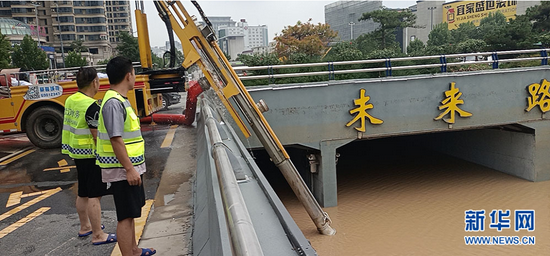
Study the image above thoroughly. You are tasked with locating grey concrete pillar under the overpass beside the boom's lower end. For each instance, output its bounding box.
[311,139,353,207]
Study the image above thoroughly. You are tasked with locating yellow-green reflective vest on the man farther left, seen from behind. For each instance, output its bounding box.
[61,92,96,159]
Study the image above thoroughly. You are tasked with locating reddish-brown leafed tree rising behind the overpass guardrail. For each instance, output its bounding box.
[359,7,416,49]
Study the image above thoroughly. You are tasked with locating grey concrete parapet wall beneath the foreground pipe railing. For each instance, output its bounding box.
[193,95,317,256]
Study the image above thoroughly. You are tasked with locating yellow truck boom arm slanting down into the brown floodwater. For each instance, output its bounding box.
[135,0,336,236]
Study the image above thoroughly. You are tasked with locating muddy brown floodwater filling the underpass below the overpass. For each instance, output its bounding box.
[275,140,550,255]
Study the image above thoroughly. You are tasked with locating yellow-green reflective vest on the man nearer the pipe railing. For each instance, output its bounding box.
[96,90,145,168]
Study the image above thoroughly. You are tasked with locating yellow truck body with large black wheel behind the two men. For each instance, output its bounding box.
[0,69,166,148]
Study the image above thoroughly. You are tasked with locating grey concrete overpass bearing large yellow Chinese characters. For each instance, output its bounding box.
[230,66,550,207]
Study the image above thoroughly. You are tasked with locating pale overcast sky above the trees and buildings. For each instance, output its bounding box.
[130,0,416,46]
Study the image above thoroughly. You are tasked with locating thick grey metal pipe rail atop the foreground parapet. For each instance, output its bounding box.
[202,106,264,256]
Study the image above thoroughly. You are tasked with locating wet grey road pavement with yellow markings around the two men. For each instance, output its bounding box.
[0,96,188,255]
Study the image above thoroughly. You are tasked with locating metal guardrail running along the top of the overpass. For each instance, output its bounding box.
[233,48,550,81]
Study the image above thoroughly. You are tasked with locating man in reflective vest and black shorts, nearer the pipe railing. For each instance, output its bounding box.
[97,56,156,256]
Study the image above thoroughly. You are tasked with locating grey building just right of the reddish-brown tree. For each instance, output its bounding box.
[325,0,382,41]
